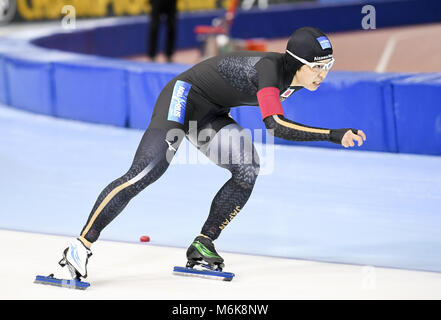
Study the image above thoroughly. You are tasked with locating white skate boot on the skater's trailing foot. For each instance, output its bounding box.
[58,239,92,280]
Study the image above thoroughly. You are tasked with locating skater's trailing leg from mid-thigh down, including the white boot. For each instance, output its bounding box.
[54,127,184,279]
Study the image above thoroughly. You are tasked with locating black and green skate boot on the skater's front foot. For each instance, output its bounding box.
[187,236,224,271]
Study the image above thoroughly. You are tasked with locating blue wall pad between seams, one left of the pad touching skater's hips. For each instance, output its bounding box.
[53,59,127,126]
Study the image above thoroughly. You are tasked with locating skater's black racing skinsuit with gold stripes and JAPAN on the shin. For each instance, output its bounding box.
[79,51,348,244]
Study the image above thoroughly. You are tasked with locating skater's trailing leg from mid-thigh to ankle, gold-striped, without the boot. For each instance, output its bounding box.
[79,128,183,247]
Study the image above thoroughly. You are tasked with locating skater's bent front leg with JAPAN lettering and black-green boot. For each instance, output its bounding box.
[187,116,259,268]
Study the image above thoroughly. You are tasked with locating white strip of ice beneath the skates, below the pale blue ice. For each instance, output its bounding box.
[0,230,441,300]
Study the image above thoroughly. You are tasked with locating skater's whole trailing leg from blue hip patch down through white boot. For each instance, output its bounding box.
[59,79,191,277]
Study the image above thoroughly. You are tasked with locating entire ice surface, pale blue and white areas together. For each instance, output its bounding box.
[0,106,441,299]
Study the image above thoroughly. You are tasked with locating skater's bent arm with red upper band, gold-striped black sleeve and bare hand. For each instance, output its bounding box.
[257,87,366,148]
